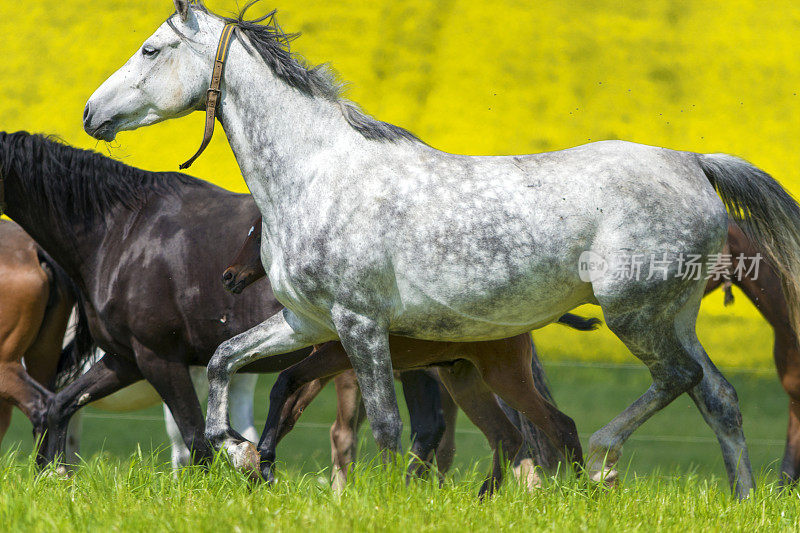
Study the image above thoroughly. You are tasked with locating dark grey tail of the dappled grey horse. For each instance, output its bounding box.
[698,154,800,332]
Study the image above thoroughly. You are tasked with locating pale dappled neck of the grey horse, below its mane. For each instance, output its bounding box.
[220,43,389,238]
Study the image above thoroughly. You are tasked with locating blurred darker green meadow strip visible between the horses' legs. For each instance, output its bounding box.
[2,358,788,479]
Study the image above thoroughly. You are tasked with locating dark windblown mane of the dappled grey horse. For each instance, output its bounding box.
[179,0,421,142]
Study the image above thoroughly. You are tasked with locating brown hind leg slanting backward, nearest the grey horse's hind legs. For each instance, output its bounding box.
[474,334,583,464]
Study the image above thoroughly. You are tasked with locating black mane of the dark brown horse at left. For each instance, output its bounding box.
[0,131,198,236]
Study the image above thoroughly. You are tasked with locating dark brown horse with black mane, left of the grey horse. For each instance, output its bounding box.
[0,132,585,486]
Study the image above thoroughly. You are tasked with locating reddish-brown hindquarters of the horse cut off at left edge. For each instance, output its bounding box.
[0,220,75,441]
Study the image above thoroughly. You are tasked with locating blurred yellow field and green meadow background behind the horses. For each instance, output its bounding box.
[0,0,800,482]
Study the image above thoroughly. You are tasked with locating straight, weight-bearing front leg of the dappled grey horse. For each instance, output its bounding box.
[332,309,403,459]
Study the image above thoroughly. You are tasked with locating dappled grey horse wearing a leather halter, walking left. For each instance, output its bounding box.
[83,0,800,498]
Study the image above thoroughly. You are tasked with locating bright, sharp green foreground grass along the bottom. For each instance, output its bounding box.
[0,446,800,531]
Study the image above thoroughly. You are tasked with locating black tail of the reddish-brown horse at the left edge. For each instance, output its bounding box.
[37,249,95,390]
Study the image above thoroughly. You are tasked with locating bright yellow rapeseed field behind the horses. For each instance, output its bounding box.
[0,0,800,366]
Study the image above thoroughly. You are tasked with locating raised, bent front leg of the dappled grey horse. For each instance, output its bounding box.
[206,309,335,472]
